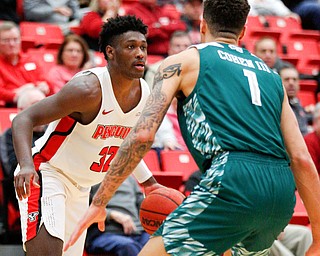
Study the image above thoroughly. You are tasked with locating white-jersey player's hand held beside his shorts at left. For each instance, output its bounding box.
[14,168,40,200]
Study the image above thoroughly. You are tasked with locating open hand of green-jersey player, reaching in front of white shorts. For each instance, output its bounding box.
[63,204,107,251]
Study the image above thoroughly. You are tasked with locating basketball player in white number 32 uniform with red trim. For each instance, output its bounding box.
[12,16,160,256]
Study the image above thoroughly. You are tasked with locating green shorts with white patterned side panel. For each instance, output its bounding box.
[154,152,295,256]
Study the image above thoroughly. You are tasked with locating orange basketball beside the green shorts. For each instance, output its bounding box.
[140,188,185,235]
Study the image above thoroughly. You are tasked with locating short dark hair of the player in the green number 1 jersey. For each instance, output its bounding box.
[203,0,250,35]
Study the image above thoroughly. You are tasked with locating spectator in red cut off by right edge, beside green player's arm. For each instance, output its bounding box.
[304,103,320,175]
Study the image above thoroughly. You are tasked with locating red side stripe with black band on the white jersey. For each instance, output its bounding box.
[40,116,77,162]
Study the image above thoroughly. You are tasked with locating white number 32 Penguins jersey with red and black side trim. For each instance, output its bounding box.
[33,67,150,187]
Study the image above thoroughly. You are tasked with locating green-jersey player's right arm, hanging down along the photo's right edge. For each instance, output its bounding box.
[281,90,320,253]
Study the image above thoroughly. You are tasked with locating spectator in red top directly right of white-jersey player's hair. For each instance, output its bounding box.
[125,0,186,56]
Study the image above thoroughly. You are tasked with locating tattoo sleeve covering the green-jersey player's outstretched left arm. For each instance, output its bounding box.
[92,63,181,206]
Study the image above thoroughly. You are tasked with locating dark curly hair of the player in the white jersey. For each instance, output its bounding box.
[99,15,148,59]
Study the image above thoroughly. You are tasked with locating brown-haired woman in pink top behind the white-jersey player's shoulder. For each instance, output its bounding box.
[48,34,89,93]
